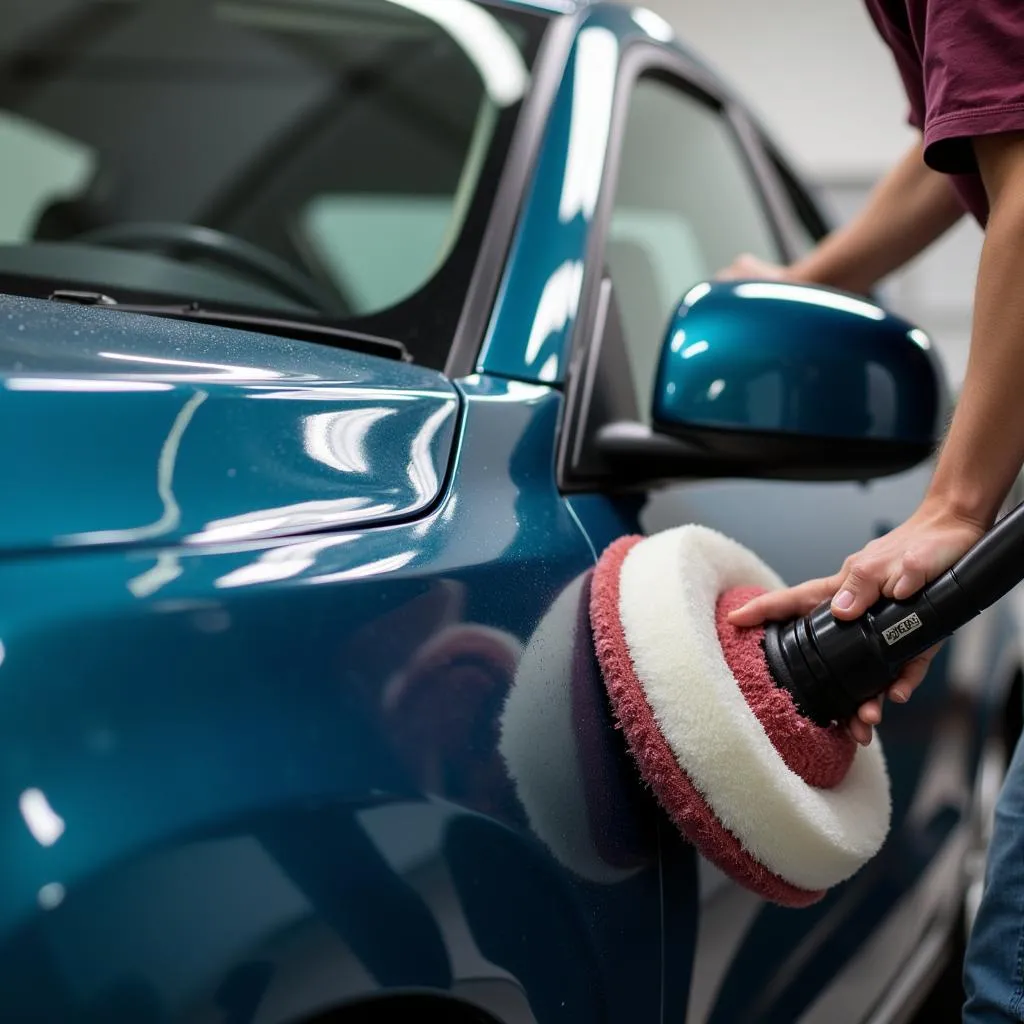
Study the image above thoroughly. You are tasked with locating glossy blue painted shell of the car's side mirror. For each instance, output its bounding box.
[651,282,944,444]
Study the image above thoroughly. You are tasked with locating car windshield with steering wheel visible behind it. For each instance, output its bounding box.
[0,0,545,368]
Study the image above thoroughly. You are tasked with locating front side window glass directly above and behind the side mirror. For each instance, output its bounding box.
[605,78,782,419]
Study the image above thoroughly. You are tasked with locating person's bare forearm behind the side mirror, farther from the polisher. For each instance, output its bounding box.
[788,143,964,294]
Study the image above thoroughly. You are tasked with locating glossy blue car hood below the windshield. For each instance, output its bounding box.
[0,296,459,551]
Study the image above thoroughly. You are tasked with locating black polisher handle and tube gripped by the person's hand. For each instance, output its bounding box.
[765,493,1024,725]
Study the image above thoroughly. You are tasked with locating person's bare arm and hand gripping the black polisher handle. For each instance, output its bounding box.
[732,133,1024,742]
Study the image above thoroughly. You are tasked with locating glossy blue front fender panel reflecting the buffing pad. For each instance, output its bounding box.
[0,376,660,1024]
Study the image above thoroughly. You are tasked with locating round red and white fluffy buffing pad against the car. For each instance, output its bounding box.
[590,525,891,906]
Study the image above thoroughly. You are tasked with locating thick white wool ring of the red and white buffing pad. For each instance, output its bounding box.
[618,524,892,890]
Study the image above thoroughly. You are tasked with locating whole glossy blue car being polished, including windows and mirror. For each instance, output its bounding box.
[0,0,1021,1024]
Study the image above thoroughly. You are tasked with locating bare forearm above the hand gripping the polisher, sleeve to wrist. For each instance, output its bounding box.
[929,145,1024,525]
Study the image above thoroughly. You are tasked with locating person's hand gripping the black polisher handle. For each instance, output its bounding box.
[729,501,986,745]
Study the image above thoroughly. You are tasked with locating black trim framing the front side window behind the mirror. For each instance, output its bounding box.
[555,41,793,494]
